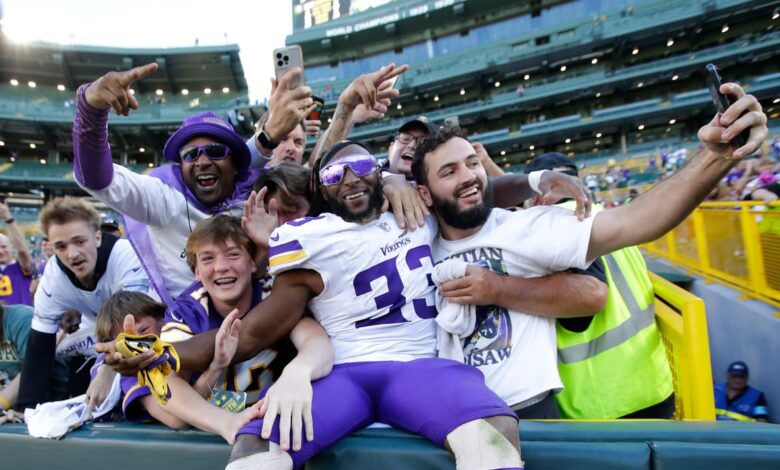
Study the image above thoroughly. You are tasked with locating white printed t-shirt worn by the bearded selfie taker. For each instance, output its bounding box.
[433,207,593,406]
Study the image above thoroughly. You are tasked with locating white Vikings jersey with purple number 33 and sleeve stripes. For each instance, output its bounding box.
[268,213,436,364]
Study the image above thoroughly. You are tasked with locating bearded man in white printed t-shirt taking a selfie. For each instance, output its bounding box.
[412,84,767,414]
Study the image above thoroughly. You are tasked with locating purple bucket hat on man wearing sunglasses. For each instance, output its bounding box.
[163,112,251,173]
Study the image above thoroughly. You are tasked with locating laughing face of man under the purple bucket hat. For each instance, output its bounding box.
[180,137,237,206]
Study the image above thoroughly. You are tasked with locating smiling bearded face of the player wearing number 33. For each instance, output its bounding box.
[320,145,384,223]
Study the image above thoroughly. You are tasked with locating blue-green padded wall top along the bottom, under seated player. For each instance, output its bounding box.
[0,421,780,470]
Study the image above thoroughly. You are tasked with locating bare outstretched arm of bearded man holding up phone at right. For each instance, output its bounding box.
[588,83,769,259]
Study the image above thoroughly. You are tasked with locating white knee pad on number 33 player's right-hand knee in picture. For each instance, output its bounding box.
[447,419,524,470]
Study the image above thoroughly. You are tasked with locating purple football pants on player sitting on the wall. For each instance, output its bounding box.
[238,358,516,467]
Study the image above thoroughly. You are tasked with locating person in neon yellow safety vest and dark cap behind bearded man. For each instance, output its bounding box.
[525,152,674,419]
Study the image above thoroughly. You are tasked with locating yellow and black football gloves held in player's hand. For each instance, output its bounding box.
[116,333,179,405]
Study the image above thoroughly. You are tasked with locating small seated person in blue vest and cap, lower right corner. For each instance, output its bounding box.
[715,361,769,423]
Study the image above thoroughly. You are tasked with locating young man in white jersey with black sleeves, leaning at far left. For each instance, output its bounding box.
[18,197,149,408]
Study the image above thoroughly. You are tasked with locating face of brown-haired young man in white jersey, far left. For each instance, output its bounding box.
[47,220,101,287]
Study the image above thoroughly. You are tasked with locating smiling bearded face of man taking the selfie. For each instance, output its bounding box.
[418,137,493,239]
